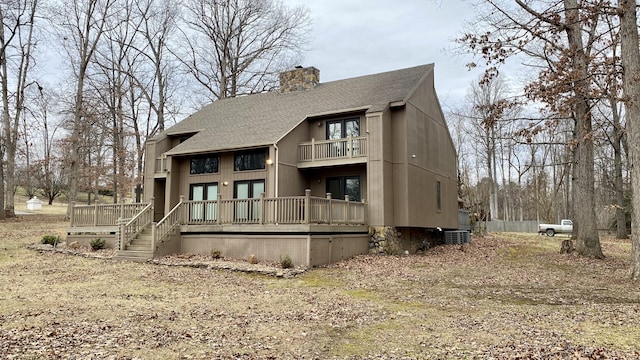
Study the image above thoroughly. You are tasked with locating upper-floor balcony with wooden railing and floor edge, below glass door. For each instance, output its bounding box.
[298,136,367,168]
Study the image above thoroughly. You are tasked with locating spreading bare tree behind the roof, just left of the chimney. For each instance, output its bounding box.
[178,0,308,100]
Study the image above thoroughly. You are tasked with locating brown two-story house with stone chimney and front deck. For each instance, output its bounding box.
[67,64,458,266]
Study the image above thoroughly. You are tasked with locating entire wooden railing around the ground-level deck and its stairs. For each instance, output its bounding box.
[71,190,367,250]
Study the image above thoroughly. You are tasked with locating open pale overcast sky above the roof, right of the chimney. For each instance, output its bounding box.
[284,0,480,111]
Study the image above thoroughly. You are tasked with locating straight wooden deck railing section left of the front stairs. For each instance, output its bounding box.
[71,203,149,227]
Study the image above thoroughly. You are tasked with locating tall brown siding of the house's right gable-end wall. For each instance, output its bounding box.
[392,69,458,228]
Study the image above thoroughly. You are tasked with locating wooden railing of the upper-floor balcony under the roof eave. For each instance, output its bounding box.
[298,136,367,162]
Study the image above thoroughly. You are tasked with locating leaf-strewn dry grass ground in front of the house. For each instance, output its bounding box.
[0,215,640,359]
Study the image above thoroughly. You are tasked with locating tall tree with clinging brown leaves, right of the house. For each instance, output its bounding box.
[460,0,603,258]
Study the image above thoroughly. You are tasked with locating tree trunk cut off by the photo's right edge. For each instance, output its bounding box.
[619,0,640,280]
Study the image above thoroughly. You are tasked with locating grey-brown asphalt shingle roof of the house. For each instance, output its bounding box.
[165,64,433,155]
